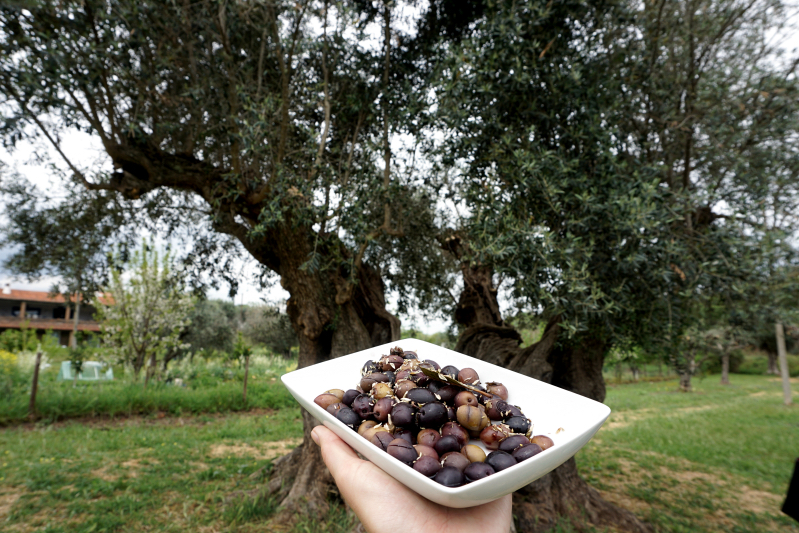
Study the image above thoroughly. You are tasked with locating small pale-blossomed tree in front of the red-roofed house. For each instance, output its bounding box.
[94,242,194,387]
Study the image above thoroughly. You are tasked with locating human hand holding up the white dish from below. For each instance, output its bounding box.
[311,426,511,533]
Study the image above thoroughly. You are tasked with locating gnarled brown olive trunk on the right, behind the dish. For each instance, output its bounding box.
[455,264,651,533]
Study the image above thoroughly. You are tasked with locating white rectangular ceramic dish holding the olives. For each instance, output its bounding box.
[281,339,610,508]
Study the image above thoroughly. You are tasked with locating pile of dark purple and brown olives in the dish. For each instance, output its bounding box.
[314,347,553,487]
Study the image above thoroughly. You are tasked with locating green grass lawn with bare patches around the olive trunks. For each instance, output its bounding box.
[0,375,799,533]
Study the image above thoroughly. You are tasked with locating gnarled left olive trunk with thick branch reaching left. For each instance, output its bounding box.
[94,139,400,521]
